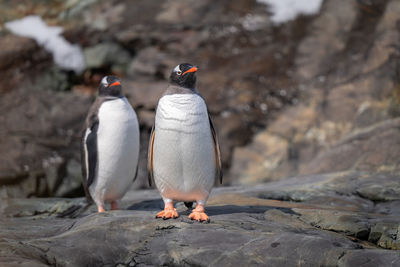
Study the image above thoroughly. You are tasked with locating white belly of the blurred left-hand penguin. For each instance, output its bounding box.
[90,98,139,202]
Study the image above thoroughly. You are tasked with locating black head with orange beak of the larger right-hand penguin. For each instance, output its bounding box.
[169,63,197,89]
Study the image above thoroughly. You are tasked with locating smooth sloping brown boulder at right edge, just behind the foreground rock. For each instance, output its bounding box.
[300,119,400,176]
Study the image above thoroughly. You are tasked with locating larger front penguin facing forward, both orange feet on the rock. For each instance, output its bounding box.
[148,63,222,222]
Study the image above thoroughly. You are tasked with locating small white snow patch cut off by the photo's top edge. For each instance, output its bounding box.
[257,0,323,24]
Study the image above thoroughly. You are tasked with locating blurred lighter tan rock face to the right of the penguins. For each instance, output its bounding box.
[231,0,400,183]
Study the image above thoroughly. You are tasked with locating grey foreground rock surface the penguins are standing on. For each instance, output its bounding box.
[0,171,400,266]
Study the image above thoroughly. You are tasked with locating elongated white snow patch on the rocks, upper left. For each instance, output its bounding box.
[5,16,85,73]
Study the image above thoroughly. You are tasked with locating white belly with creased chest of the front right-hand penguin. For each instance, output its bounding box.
[153,94,216,201]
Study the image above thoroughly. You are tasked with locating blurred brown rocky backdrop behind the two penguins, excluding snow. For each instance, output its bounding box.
[0,0,400,197]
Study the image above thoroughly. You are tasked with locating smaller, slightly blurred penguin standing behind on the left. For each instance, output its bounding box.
[81,76,139,212]
